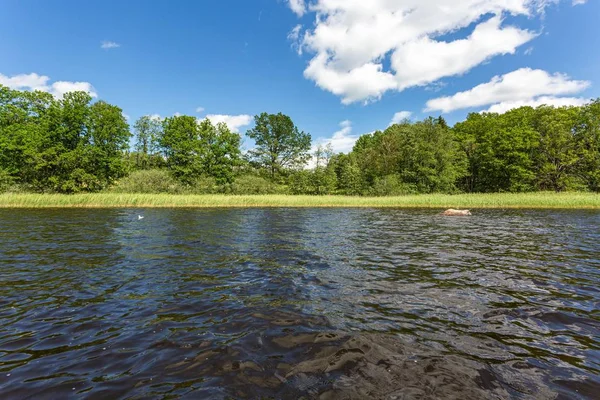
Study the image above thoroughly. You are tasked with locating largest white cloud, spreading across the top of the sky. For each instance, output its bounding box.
[289,0,580,104]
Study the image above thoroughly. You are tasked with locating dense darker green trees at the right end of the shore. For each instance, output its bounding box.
[454,101,600,192]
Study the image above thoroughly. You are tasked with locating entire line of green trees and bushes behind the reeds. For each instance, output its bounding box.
[0,85,600,196]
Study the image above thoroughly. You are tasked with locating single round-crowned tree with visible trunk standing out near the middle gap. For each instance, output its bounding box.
[246,113,311,179]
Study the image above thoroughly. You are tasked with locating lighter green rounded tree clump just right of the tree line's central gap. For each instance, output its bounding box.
[337,118,466,193]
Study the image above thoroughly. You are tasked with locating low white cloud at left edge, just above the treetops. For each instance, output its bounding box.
[0,73,98,99]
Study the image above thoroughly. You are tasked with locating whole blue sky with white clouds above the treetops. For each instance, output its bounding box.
[0,0,600,151]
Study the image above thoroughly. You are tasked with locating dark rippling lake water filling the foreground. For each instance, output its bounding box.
[0,209,600,400]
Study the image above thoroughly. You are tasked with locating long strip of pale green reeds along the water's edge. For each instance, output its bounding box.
[0,192,600,209]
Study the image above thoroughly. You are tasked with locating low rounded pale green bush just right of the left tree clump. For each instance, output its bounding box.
[112,169,183,194]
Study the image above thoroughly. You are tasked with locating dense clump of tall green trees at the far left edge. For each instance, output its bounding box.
[0,86,130,193]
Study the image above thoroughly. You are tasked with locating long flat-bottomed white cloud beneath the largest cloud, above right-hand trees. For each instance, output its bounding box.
[426,68,590,113]
